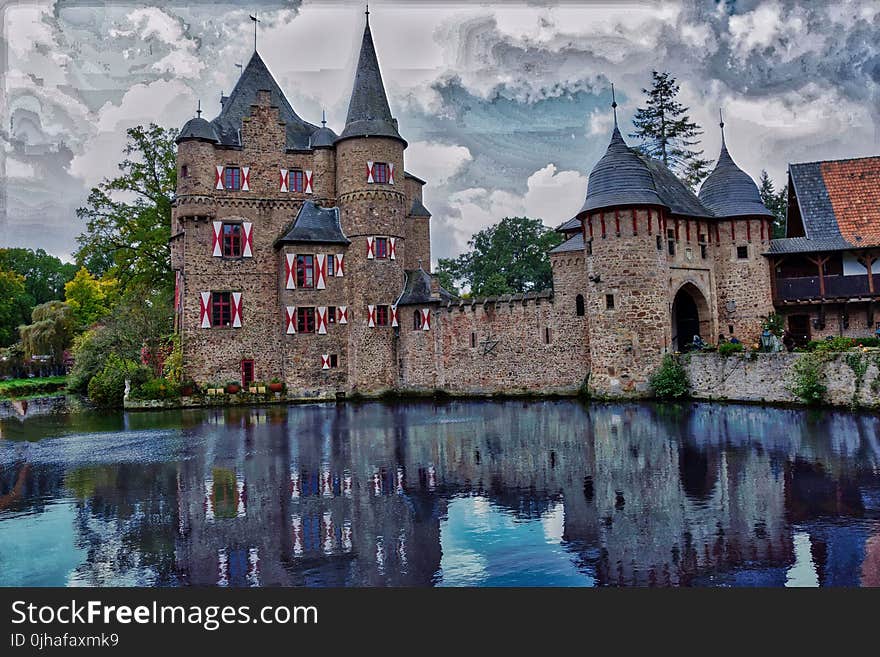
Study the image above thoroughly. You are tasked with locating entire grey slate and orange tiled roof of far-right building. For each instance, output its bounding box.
[788,156,880,248]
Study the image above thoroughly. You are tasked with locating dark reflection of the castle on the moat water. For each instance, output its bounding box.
[162,402,880,586]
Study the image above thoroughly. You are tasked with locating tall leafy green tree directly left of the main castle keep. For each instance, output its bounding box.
[75,124,177,294]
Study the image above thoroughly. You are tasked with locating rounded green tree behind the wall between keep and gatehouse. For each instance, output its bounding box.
[438,217,562,296]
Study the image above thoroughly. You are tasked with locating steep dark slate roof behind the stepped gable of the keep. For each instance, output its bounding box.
[211,51,318,150]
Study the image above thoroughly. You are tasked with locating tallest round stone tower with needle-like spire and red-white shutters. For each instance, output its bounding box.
[335,14,406,393]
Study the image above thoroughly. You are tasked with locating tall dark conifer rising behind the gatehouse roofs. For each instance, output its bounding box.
[630,71,710,189]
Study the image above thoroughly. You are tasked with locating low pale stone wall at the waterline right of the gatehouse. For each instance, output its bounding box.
[684,353,880,408]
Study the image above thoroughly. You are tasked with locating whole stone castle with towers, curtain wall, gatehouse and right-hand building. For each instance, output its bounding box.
[170,10,880,399]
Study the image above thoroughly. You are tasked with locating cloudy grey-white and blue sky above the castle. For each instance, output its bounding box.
[0,0,880,258]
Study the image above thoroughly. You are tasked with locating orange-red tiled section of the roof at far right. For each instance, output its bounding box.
[820,156,880,246]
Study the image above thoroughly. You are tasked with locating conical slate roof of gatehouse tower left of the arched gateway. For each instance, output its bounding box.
[581,124,663,212]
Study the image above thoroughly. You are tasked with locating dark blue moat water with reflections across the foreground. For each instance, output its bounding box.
[0,401,880,586]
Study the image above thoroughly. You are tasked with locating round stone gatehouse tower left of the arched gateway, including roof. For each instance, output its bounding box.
[578,123,670,396]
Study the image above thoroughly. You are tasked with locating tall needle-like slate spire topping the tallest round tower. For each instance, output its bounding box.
[339,17,406,143]
